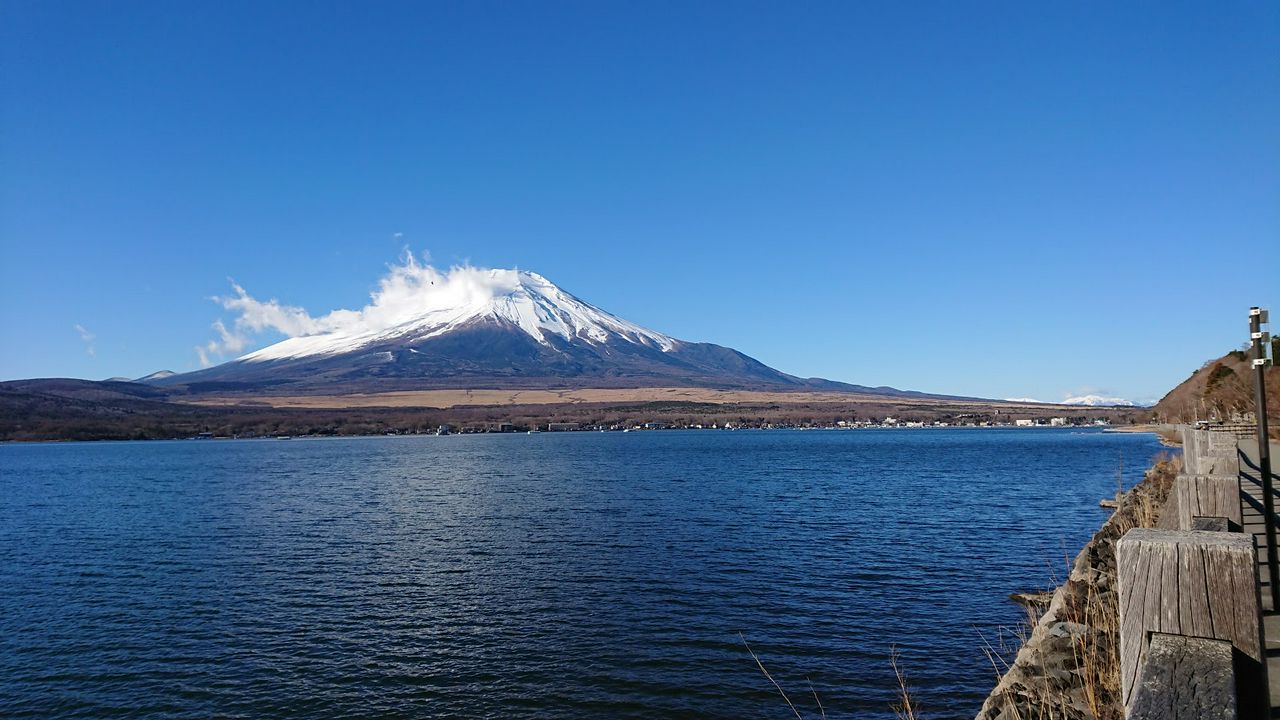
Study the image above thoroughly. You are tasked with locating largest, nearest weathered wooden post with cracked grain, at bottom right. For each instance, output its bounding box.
[1116,528,1268,716]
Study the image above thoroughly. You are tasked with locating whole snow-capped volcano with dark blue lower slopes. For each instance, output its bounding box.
[154,270,942,396]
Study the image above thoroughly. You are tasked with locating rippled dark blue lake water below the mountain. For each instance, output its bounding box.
[0,429,1160,719]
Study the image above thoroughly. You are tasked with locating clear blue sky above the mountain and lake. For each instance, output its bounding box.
[0,0,1280,400]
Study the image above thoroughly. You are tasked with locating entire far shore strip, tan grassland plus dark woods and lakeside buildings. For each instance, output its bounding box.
[0,380,1146,441]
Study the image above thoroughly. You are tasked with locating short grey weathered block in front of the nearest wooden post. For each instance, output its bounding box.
[1128,633,1239,720]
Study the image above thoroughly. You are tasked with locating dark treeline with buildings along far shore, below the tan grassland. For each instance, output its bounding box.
[0,380,1142,441]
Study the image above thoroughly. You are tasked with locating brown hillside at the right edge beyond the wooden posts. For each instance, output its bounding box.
[1152,347,1280,428]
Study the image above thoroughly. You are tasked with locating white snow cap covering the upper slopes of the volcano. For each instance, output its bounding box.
[239,269,678,363]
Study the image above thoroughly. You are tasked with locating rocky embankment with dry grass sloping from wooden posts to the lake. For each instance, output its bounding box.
[978,459,1179,720]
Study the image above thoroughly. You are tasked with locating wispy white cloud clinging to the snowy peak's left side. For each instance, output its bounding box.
[196,251,517,368]
